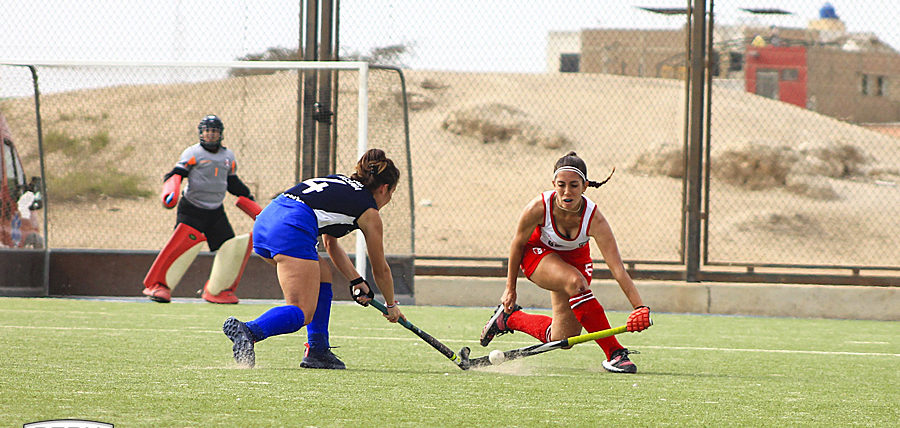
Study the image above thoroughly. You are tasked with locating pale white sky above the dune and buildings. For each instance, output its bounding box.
[0,0,900,85]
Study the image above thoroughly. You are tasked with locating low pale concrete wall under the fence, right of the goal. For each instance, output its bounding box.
[415,276,900,321]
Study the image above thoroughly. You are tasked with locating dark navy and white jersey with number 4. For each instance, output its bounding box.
[284,174,378,238]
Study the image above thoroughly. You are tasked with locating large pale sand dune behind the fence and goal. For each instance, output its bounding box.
[0,71,900,266]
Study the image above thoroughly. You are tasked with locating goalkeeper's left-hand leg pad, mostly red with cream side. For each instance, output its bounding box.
[144,223,206,300]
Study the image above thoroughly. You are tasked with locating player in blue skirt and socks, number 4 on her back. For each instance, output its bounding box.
[222,149,405,369]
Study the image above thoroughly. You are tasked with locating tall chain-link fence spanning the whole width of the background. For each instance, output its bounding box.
[0,0,900,274]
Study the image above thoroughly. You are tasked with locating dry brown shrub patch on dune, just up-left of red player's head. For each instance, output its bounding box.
[441,103,571,149]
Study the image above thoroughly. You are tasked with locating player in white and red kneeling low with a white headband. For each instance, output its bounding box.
[481,152,651,373]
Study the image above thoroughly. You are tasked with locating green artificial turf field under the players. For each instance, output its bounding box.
[0,298,900,427]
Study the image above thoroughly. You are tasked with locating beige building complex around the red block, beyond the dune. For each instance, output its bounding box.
[547,19,900,123]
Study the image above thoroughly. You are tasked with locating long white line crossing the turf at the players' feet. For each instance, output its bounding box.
[0,325,900,357]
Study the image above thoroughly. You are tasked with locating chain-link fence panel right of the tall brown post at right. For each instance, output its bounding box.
[706,2,900,268]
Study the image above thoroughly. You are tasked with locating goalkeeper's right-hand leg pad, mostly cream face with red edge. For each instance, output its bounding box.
[202,233,253,304]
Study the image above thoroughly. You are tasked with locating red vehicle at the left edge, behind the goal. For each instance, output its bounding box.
[0,114,44,248]
